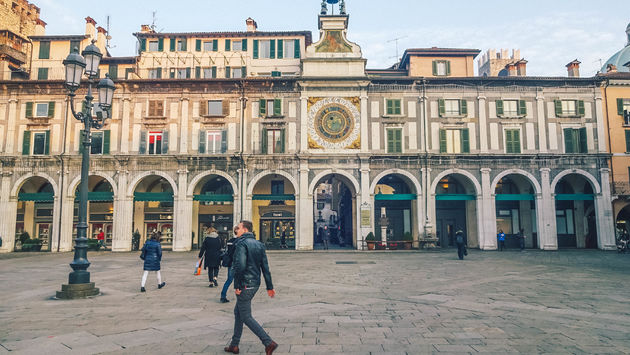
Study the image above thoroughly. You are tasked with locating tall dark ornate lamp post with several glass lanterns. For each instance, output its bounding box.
[57,42,115,299]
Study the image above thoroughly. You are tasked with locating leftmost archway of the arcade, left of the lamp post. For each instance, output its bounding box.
[15,176,55,251]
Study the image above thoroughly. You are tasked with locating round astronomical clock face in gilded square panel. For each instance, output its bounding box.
[308,98,360,149]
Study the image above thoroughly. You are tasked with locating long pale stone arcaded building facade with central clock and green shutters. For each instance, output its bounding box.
[0,3,614,252]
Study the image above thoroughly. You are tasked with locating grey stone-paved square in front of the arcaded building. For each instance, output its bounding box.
[0,250,630,354]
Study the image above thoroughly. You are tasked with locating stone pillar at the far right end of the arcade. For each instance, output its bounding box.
[595,168,616,250]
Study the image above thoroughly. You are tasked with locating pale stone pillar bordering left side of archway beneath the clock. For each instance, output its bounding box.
[295,160,313,250]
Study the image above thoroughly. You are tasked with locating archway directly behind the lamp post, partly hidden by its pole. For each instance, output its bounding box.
[72,175,114,250]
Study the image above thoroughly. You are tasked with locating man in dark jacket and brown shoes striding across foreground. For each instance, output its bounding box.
[224,221,278,355]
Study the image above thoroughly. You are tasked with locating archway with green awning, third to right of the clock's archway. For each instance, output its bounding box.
[435,174,479,248]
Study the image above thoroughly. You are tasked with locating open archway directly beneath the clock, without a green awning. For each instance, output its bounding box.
[313,174,357,249]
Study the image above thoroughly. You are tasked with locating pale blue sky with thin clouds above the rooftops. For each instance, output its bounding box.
[33,0,630,76]
